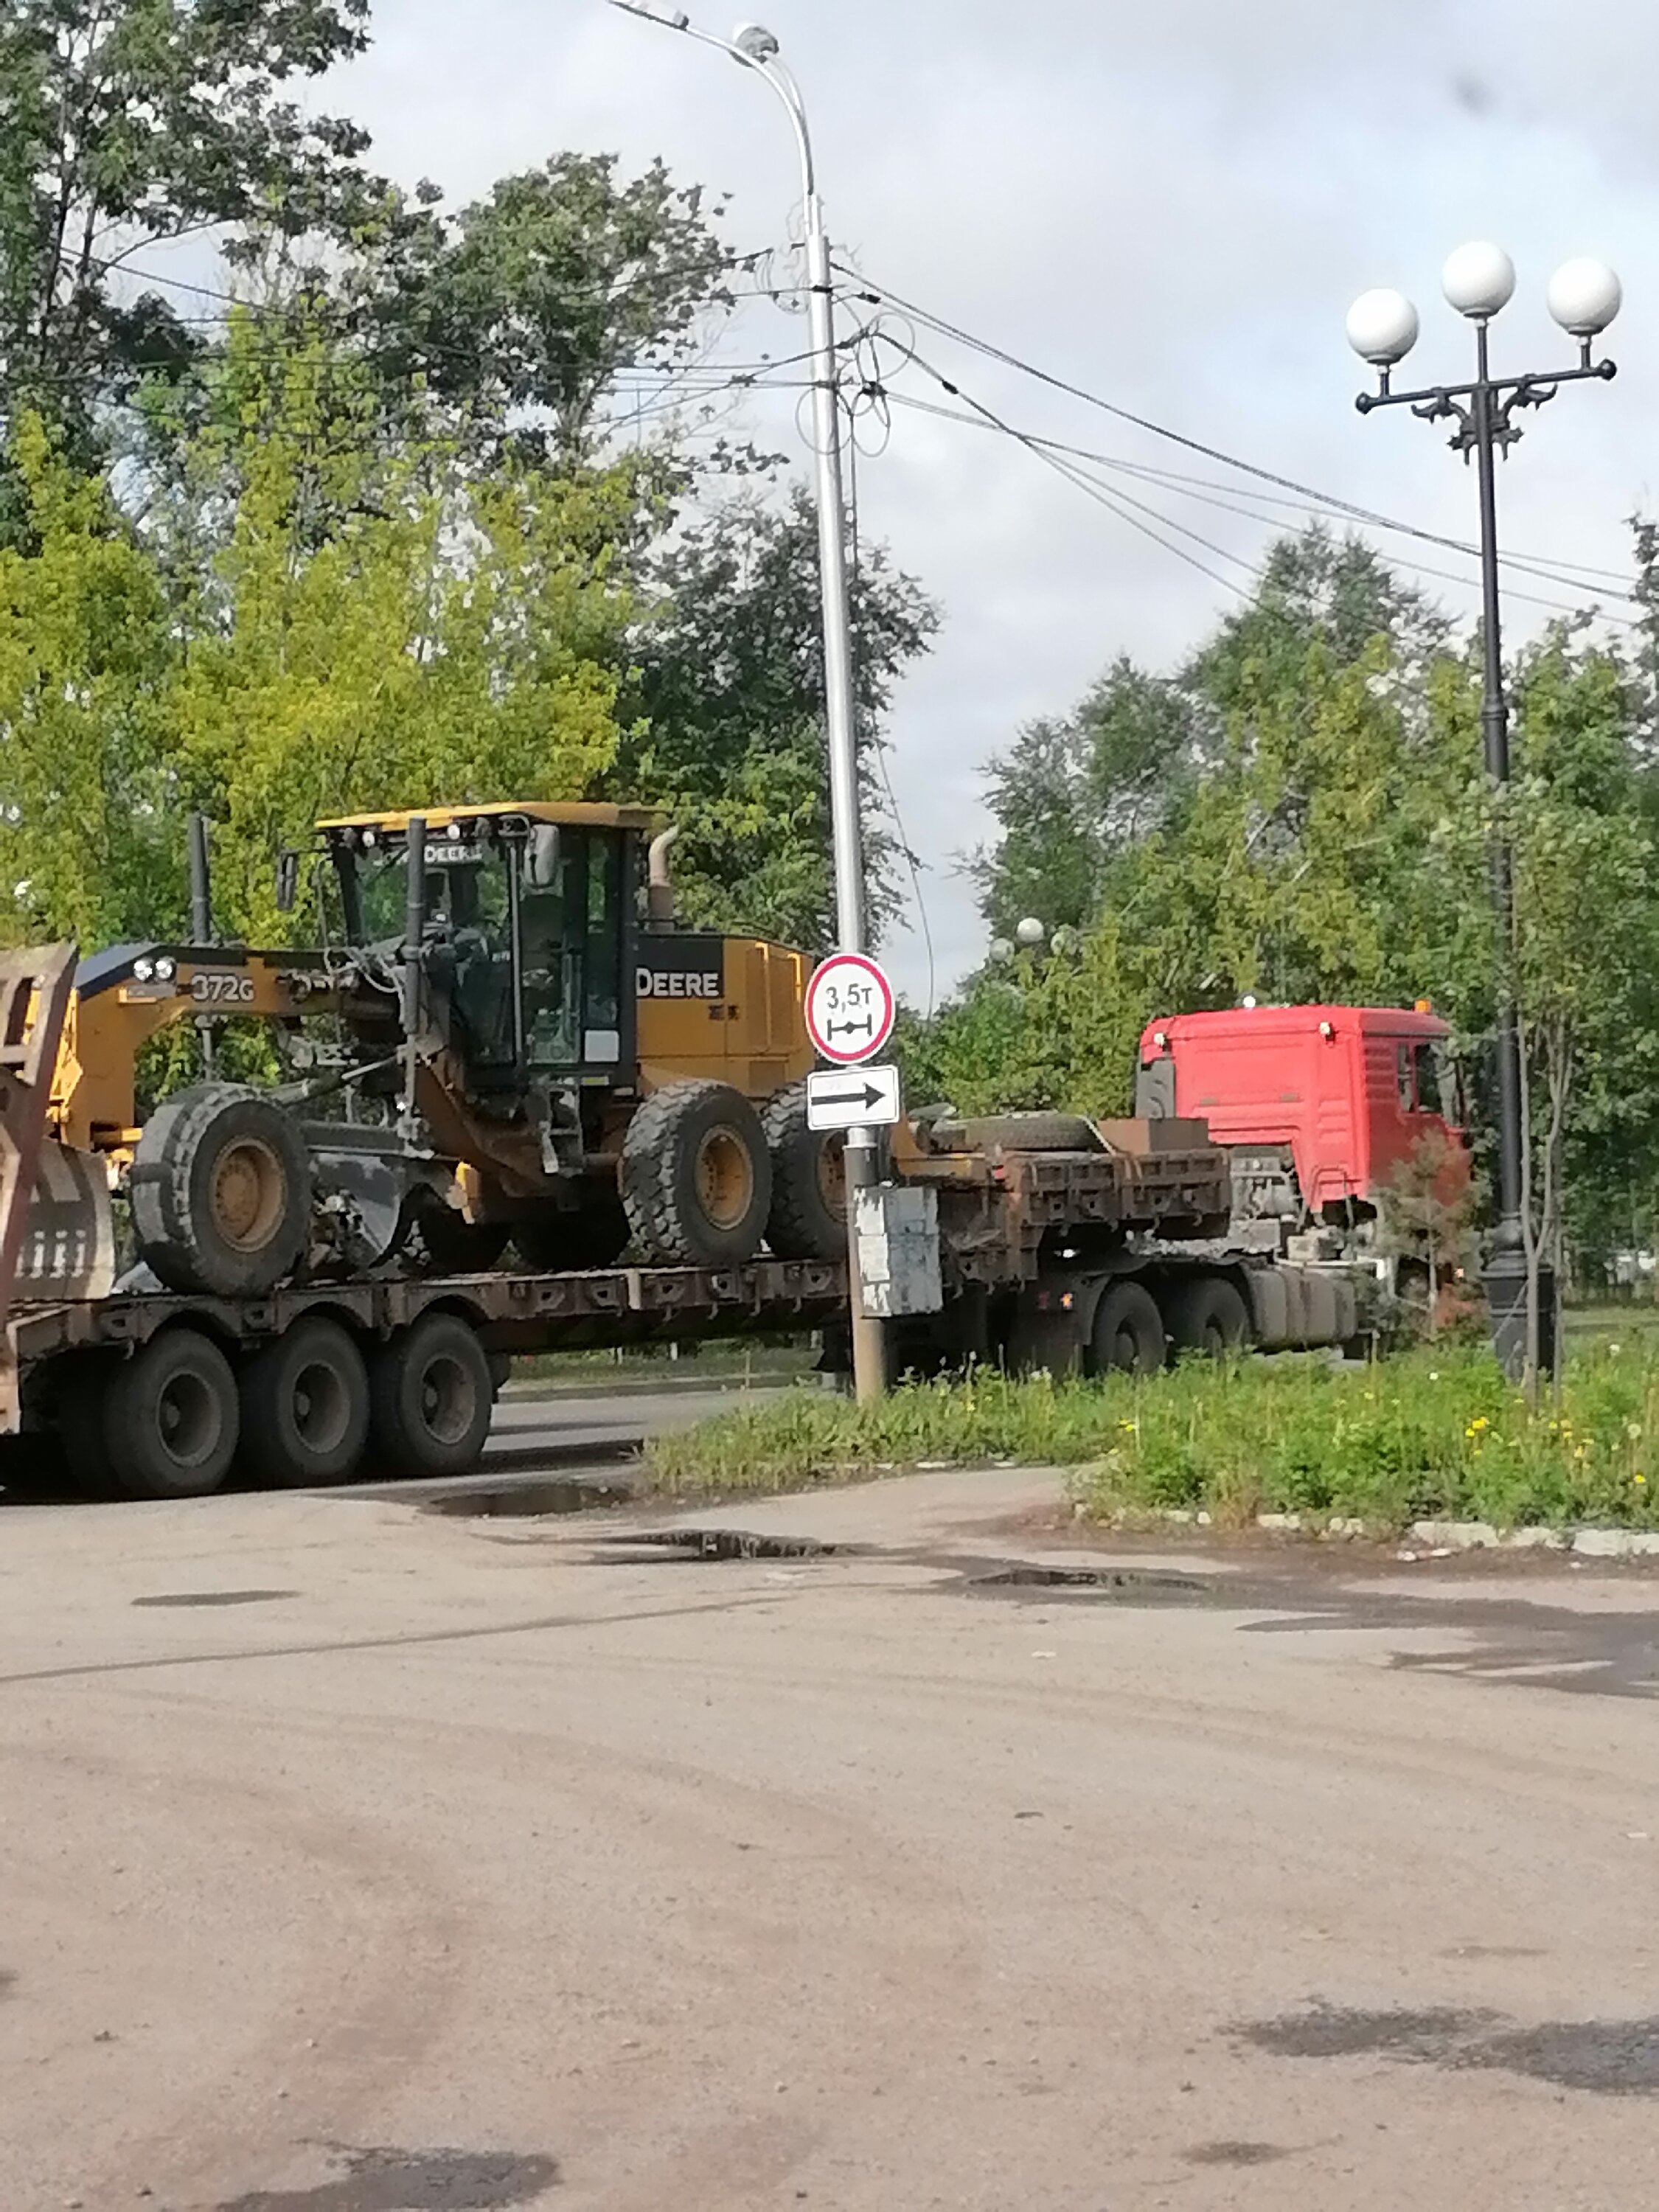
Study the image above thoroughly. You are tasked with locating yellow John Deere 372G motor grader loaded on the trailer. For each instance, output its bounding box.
[18,801,845,1296]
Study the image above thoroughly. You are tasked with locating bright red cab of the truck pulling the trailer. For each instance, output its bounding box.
[1135,1006,1469,1221]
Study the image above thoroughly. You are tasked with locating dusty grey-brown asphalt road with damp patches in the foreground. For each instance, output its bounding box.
[0,1475,1659,2212]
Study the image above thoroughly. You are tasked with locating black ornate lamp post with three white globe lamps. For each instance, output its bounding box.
[1347,246,1621,1378]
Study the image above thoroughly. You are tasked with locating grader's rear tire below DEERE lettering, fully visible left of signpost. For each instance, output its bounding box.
[617,1082,772,1267]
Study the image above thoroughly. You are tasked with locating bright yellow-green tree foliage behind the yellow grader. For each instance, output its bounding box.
[0,341,635,942]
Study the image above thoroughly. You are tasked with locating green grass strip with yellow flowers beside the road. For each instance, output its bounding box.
[646,1338,1659,1528]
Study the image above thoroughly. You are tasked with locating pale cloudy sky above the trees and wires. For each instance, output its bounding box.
[310,0,1659,998]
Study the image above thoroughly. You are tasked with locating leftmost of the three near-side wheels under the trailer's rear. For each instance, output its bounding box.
[102,1329,241,1498]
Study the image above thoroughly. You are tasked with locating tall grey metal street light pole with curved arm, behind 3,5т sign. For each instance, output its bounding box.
[611,0,887,1402]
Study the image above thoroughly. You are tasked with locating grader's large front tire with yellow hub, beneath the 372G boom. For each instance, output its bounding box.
[131,1084,312,1298]
